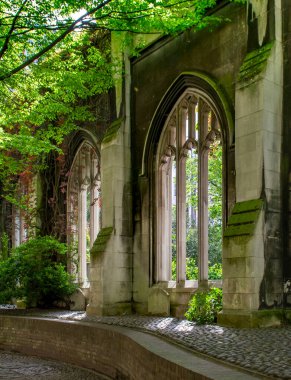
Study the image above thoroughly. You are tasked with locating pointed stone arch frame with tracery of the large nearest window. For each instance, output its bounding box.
[143,73,233,284]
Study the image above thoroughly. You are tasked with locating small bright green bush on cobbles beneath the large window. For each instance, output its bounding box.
[185,288,222,324]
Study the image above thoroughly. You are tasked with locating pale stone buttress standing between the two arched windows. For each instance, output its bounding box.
[87,51,132,315]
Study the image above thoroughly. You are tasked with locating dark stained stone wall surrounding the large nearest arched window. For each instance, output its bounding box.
[132,4,247,312]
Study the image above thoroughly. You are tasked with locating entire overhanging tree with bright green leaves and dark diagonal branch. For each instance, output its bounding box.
[0,0,246,200]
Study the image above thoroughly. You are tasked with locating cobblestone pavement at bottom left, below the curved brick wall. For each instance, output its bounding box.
[0,351,107,380]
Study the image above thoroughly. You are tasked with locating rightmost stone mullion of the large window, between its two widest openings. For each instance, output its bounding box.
[198,100,208,286]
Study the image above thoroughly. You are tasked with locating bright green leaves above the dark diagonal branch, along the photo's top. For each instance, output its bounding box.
[0,0,226,80]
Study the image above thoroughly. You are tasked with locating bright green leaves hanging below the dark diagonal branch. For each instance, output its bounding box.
[0,32,112,192]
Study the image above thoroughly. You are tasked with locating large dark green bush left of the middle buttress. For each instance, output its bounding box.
[0,236,76,307]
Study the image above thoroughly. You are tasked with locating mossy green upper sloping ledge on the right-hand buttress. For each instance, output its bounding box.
[238,43,273,81]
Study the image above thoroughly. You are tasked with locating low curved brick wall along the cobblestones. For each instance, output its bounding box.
[0,316,209,380]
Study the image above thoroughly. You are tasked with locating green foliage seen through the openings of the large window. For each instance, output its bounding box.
[172,141,222,280]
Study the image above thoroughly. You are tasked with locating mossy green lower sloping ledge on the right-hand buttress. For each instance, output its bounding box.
[224,199,264,237]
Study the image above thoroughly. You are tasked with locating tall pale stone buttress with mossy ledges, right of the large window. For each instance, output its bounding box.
[219,1,283,326]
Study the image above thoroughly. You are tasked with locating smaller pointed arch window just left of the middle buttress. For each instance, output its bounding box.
[67,141,101,287]
